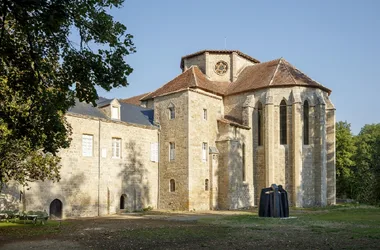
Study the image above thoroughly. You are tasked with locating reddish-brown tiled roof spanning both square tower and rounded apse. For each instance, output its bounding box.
[141,56,331,100]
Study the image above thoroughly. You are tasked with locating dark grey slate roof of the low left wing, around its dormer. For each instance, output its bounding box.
[68,97,154,126]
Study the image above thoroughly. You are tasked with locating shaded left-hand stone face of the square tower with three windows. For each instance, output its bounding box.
[154,91,189,210]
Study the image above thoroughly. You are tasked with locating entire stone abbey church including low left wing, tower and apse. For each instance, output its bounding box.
[0,50,335,218]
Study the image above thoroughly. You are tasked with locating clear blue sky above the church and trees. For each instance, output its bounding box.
[99,0,380,134]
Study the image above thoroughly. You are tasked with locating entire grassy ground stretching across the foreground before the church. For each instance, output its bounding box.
[0,205,380,249]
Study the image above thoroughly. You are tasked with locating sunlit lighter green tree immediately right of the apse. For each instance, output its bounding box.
[336,121,356,198]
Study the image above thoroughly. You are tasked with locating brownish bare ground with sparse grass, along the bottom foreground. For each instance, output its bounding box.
[0,212,380,250]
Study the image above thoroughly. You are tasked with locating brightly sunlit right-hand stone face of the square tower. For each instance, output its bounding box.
[188,90,223,210]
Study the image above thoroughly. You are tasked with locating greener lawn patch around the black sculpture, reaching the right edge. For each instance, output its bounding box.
[200,206,380,239]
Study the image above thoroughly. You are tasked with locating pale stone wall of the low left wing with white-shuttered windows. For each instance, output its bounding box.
[15,115,158,218]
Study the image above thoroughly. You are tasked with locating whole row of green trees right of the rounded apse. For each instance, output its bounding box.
[336,121,380,204]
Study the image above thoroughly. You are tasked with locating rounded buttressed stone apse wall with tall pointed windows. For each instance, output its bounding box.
[224,87,335,206]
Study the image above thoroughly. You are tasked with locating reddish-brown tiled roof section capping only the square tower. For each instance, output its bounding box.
[141,66,228,100]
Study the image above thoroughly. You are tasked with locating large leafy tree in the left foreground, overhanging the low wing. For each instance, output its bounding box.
[0,0,135,188]
